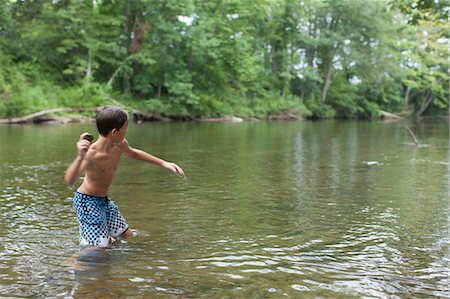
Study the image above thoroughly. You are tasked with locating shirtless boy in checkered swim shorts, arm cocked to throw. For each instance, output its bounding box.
[64,106,184,247]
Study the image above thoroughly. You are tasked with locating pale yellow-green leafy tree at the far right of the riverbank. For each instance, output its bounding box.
[394,0,450,117]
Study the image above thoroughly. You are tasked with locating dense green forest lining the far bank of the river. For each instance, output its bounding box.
[0,0,450,119]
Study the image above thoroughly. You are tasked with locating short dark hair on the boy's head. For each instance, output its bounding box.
[95,106,128,137]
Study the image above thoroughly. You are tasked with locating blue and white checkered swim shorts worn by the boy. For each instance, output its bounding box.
[73,192,128,247]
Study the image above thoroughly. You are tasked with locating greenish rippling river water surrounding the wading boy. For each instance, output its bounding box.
[0,121,450,298]
